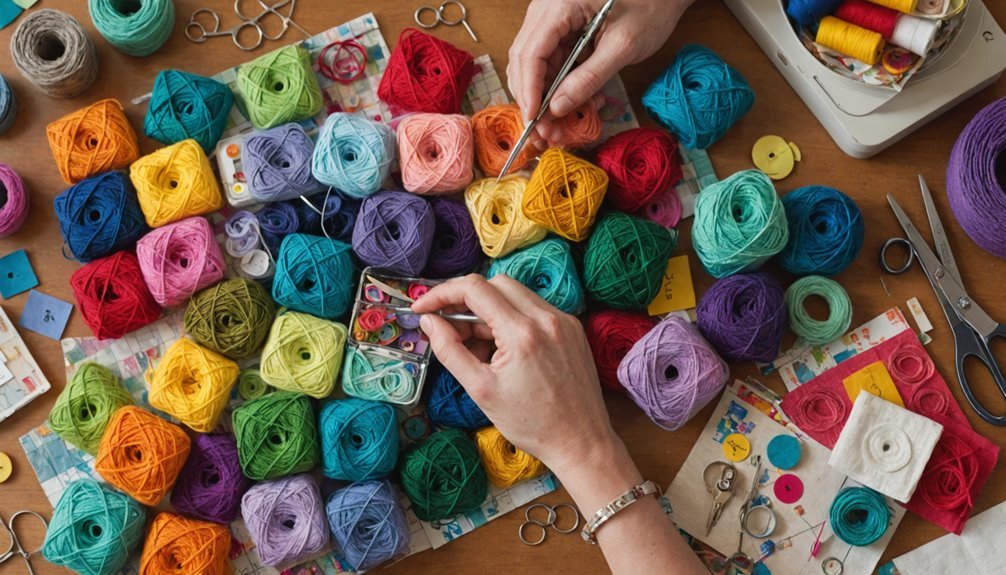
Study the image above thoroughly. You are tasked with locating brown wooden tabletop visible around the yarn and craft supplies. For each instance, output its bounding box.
[0,0,1006,575]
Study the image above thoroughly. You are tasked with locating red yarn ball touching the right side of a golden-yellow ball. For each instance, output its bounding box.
[594,128,681,212]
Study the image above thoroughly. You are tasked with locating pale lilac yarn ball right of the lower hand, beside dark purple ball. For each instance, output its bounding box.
[619,316,730,431]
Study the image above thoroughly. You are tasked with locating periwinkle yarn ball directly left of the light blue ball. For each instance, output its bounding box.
[241,124,324,203]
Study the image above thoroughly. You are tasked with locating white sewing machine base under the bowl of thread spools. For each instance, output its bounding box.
[724,0,1006,158]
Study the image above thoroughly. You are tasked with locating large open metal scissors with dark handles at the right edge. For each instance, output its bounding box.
[880,176,1006,425]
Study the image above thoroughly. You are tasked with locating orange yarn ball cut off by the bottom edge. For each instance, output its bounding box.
[140,512,232,575]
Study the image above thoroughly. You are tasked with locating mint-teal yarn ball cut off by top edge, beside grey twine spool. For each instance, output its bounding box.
[88,0,175,56]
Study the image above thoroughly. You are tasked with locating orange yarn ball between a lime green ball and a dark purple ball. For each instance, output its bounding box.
[95,405,189,507]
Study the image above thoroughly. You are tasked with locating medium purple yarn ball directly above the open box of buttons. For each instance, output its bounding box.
[353,191,437,277]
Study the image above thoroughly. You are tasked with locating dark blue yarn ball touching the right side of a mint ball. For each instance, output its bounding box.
[779,186,866,277]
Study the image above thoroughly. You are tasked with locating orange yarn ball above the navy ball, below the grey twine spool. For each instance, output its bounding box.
[45,99,140,184]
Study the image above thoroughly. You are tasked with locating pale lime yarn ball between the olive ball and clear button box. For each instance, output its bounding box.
[260,312,347,397]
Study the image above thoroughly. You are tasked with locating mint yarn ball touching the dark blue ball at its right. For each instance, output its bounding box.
[692,170,790,278]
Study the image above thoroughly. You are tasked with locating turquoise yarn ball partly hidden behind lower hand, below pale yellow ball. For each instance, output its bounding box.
[487,237,583,314]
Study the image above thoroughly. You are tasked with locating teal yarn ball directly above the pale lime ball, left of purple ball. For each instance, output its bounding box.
[273,233,355,320]
